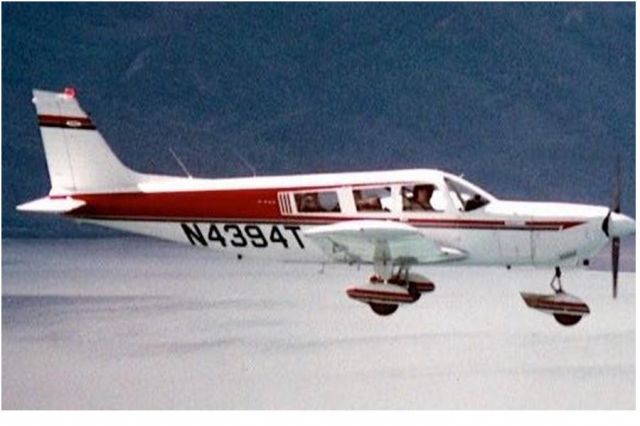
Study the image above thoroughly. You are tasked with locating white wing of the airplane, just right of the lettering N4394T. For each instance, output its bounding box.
[304,220,466,265]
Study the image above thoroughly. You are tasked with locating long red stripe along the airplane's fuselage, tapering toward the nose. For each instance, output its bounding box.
[63,188,583,231]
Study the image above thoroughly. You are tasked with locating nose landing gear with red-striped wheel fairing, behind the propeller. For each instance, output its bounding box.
[520,266,589,326]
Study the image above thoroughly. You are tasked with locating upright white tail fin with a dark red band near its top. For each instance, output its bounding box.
[33,88,143,196]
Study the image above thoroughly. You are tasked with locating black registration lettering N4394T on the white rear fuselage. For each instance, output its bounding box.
[180,223,304,249]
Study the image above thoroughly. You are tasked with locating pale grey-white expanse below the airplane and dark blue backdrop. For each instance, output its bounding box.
[2,238,635,409]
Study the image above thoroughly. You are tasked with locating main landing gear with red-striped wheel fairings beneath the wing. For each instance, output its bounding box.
[347,266,435,316]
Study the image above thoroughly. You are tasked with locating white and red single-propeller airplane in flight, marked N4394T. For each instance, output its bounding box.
[17,88,635,326]
